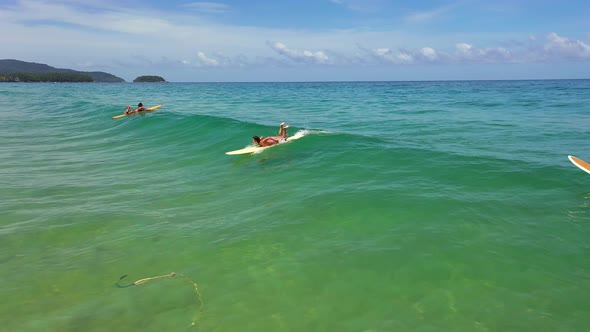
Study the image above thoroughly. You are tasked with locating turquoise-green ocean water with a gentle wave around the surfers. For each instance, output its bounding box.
[0,80,590,332]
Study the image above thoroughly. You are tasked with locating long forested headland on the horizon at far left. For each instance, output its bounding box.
[0,59,125,83]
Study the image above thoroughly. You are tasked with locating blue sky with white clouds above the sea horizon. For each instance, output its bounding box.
[0,0,590,82]
